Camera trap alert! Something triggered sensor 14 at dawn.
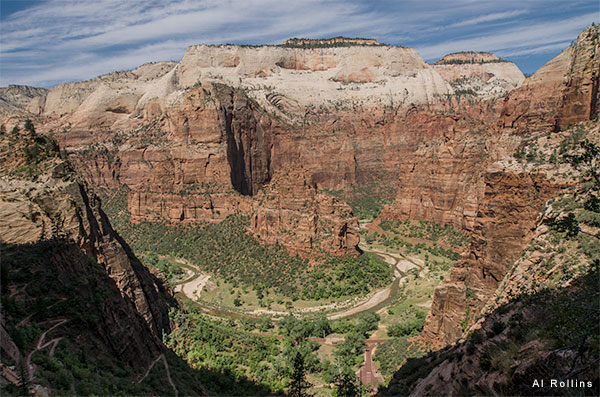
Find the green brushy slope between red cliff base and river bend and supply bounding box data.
[103,187,391,300]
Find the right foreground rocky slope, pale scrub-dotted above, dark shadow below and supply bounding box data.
[380,131,600,396]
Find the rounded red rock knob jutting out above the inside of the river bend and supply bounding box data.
[250,167,359,255]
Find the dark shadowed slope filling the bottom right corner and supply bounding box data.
[377,272,600,396]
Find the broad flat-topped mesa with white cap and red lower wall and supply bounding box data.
[0,43,514,251]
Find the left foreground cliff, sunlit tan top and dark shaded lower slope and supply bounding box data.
[0,132,203,394]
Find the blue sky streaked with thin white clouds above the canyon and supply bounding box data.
[0,0,600,87]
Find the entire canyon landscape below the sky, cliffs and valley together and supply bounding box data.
[0,24,600,396]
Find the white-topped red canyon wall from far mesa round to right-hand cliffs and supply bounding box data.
[1,26,600,372]
